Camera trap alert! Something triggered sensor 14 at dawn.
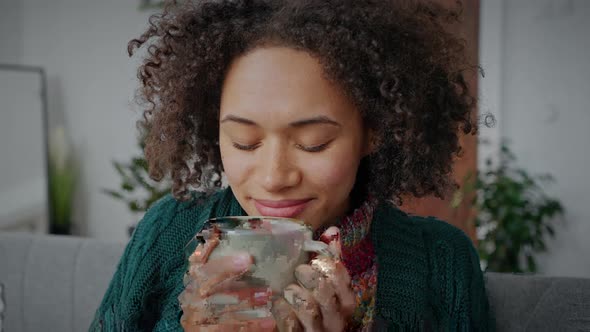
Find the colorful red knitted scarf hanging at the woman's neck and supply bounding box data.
[314,200,377,331]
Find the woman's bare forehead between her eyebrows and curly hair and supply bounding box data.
[221,47,356,121]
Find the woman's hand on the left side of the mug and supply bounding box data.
[179,230,275,332]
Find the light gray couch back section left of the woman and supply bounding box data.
[0,233,124,332]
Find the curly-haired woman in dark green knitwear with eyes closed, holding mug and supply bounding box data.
[91,0,492,331]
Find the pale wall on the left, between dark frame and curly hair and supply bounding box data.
[0,0,155,240]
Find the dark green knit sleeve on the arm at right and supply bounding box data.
[429,219,494,331]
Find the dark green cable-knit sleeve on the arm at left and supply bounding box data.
[89,195,177,331]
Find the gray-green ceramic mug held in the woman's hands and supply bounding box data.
[185,216,331,320]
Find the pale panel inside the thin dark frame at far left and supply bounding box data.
[0,69,47,232]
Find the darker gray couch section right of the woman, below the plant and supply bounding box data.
[486,273,590,332]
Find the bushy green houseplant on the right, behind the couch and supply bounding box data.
[462,142,563,273]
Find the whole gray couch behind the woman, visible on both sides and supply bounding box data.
[0,233,590,332]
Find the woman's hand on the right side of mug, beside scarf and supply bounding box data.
[273,227,356,332]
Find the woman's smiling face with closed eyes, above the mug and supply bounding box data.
[219,47,368,229]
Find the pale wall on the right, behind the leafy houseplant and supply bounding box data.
[480,0,590,277]
